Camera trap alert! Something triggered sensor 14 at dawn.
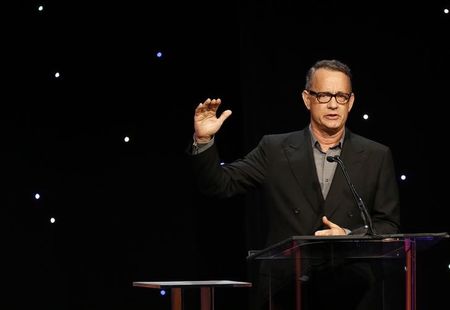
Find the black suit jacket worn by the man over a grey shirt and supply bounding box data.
[192,128,400,245]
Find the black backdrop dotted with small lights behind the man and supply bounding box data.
[0,0,450,310]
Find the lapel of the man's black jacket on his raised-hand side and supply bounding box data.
[284,129,324,213]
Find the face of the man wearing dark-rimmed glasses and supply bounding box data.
[302,68,355,134]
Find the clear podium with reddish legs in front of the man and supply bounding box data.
[247,232,449,310]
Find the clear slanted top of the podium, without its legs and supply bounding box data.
[247,232,450,260]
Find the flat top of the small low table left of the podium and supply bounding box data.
[133,280,252,288]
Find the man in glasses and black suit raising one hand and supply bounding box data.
[191,60,400,309]
